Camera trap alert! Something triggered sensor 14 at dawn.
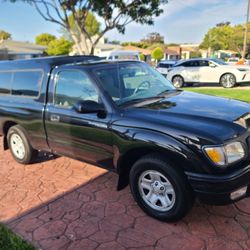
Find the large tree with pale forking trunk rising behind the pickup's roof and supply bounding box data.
[9,0,168,54]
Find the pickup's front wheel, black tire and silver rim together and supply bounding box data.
[129,155,194,222]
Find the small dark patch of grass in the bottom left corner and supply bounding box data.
[0,224,35,250]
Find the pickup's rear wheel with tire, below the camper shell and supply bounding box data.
[7,125,38,164]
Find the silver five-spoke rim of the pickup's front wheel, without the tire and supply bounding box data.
[138,170,176,212]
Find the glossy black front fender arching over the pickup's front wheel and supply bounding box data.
[113,126,206,189]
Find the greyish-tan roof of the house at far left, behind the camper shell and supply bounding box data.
[0,40,47,54]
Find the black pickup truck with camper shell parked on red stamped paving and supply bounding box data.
[0,56,250,221]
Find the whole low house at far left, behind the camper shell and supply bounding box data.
[0,40,47,60]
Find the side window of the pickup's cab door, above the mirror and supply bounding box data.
[54,70,99,108]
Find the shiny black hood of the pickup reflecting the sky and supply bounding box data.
[119,91,250,143]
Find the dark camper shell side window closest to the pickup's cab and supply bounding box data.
[12,71,43,97]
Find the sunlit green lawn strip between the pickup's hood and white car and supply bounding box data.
[184,88,250,102]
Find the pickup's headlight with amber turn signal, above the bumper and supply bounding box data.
[204,142,245,166]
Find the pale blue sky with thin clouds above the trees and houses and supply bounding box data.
[0,0,247,43]
